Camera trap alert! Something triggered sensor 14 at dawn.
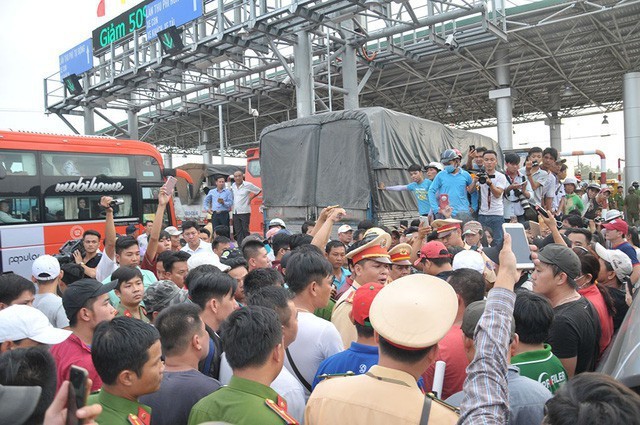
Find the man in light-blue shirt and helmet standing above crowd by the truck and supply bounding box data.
[429,149,476,222]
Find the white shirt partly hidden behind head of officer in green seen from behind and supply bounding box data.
[219,353,307,425]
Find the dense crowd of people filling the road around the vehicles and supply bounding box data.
[0,148,640,425]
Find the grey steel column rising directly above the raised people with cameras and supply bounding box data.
[494,46,513,150]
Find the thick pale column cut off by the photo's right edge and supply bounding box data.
[622,72,640,187]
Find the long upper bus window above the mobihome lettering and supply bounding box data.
[42,153,131,177]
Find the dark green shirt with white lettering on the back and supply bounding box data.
[511,344,568,394]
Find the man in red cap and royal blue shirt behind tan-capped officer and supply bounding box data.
[312,283,384,388]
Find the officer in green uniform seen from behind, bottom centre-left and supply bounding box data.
[189,305,298,425]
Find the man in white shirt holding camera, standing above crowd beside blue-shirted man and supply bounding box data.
[474,150,508,246]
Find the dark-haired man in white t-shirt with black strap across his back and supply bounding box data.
[285,248,343,398]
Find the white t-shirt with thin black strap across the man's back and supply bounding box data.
[284,311,343,399]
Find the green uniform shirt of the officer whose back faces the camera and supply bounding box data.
[189,375,284,425]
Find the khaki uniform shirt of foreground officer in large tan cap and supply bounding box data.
[304,366,458,425]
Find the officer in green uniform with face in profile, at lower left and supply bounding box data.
[88,317,164,425]
